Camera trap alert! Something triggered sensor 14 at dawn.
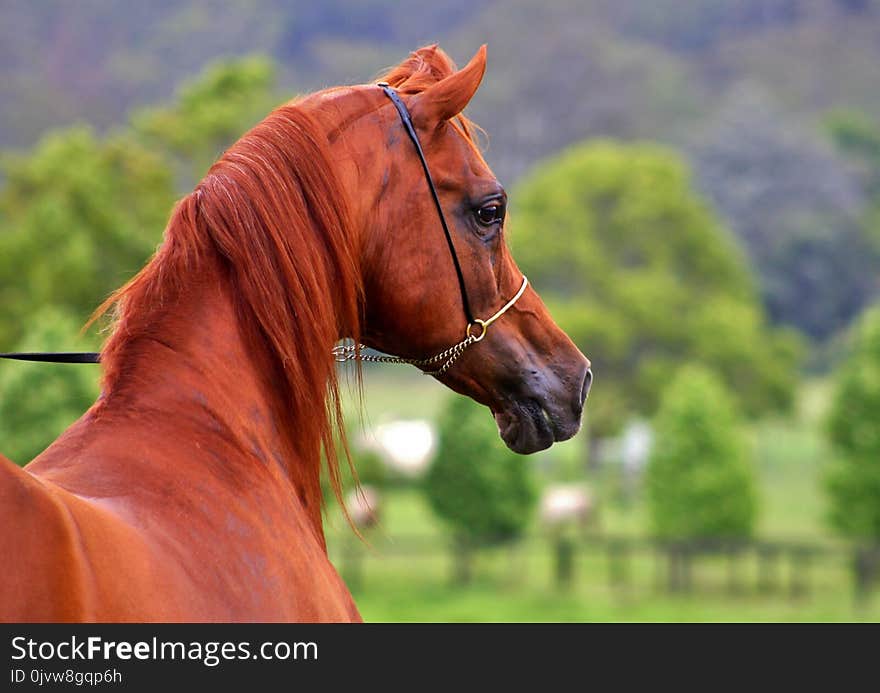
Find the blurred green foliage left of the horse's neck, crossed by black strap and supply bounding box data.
[0,59,288,475]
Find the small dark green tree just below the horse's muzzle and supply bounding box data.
[424,397,537,581]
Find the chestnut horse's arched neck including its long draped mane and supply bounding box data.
[55,105,362,534]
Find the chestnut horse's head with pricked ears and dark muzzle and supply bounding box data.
[326,46,592,453]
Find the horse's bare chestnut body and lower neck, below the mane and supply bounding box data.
[0,262,359,621]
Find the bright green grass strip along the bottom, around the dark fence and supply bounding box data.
[330,491,880,621]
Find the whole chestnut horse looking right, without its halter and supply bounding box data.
[0,46,589,621]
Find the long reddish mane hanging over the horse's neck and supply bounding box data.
[92,103,362,512]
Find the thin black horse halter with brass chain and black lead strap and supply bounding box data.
[0,82,529,375]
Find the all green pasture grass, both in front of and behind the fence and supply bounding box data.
[327,368,880,621]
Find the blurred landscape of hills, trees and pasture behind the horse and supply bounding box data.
[0,0,880,621]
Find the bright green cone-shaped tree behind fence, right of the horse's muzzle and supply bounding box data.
[645,366,757,539]
